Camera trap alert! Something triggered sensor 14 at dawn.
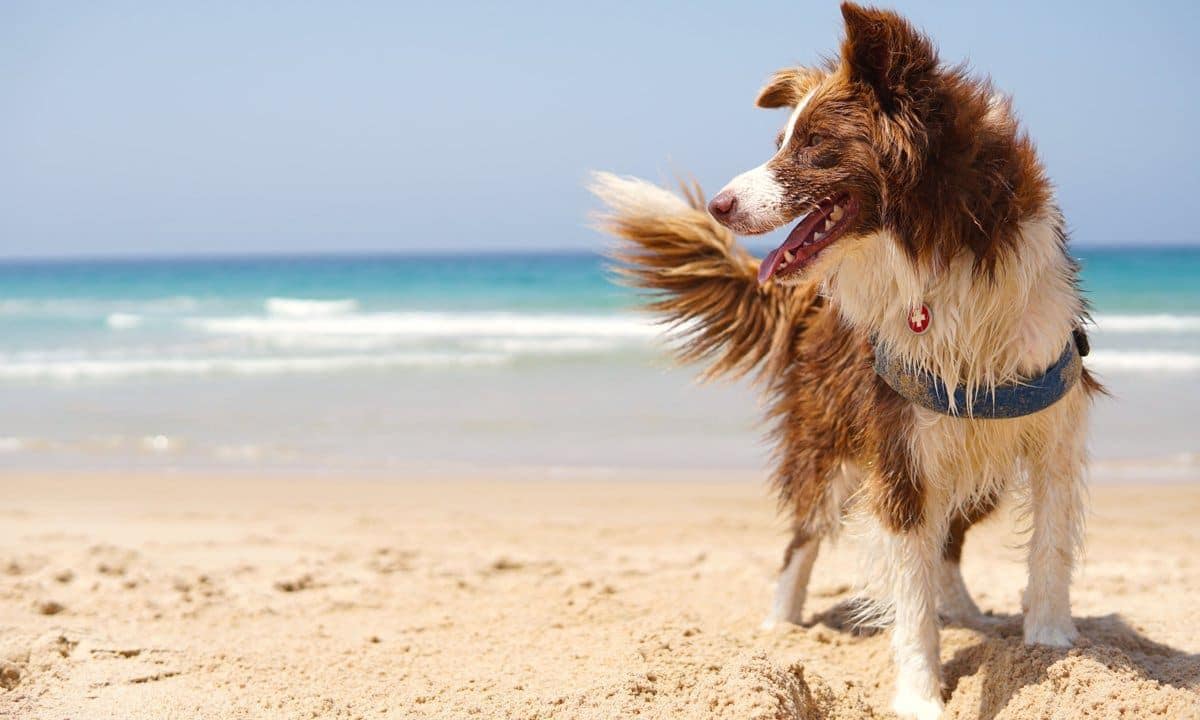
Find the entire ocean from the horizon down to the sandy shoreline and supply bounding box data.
[0,248,1200,476]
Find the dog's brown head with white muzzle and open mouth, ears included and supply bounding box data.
[709,2,960,282]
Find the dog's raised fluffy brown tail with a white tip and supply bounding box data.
[590,173,815,379]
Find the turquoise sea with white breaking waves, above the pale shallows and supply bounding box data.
[0,248,1200,380]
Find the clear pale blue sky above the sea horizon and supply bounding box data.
[0,0,1200,257]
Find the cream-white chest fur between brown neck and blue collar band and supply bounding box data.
[827,211,1082,410]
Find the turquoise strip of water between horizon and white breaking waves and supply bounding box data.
[7,247,1200,318]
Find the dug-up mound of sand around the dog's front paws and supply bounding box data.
[496,617,1200,720]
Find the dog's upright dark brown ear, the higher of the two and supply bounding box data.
[841,2,937,113]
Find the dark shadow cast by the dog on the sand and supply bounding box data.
[804,599,1200,720]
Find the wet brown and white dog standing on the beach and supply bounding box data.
[593,4,1102,719]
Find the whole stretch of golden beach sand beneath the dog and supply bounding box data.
[0,470,1200,720]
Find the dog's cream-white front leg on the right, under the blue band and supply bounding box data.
[1024,415,1085,648]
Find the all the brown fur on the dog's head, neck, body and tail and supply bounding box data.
[590,4,1103,619]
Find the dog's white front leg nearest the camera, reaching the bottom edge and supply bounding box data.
[886,520,944,720]
